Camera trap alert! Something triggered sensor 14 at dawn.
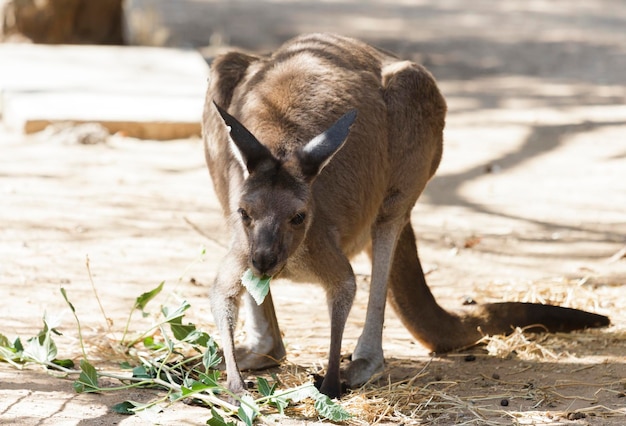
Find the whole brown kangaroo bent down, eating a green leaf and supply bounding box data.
[203,34,609,397]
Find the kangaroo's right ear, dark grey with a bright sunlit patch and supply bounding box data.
[298,109,357,180]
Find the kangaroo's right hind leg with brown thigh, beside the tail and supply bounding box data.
[346,61,446,386]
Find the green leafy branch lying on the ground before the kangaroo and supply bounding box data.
[0,266,350,426]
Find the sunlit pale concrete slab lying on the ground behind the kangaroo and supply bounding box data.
[0,44,209,140]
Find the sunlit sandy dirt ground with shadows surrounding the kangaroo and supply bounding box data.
[0,1,626,425]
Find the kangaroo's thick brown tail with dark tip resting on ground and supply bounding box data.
[388,223,609,352]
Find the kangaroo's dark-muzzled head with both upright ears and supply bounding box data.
[216,104,356,276]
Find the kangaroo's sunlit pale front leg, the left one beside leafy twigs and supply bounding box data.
[209,251,246,394]
